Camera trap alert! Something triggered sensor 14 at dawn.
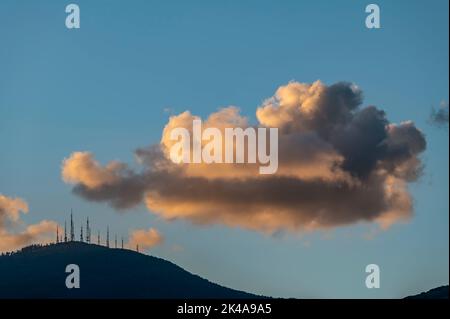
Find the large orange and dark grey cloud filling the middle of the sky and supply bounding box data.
[62,81,426,233]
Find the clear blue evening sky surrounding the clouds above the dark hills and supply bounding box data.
[0,0,449,298]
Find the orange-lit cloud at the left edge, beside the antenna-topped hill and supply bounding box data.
[0,194,57,251]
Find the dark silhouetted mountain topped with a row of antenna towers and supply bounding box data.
[0,242,259,299]
